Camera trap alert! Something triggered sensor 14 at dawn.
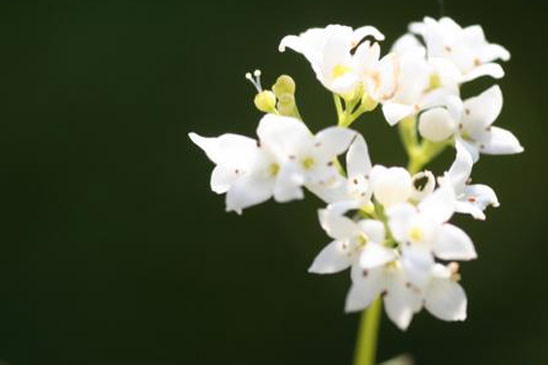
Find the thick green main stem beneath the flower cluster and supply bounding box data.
[354,297,382,365]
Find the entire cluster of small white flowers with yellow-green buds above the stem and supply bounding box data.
[189,17,523,329]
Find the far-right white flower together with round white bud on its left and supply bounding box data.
[419,85,523,161]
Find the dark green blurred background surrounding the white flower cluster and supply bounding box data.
[0,0,548,365]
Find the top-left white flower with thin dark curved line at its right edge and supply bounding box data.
[279,25,384,94]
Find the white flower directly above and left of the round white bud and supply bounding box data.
[382,40,460,125]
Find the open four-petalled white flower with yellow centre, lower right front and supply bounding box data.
[386,186,477,287]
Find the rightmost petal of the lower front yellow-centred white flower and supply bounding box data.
[434,223,478,260]
